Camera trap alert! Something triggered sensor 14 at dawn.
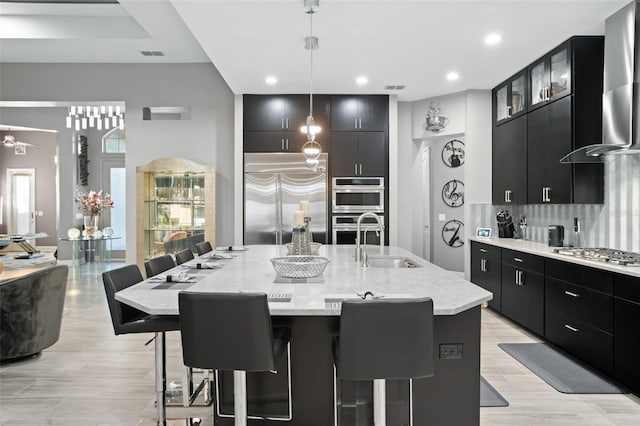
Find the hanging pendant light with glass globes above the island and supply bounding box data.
[300,0,322,170]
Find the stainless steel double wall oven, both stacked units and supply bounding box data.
[331,176,385,244]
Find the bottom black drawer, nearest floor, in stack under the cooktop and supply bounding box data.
[544,310,613,375]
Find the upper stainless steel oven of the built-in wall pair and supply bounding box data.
[331,177,384,213]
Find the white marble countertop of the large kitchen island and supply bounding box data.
[116,245,493,315]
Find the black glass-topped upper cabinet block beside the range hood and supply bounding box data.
[492,36,604,204]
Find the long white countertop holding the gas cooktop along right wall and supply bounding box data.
[469,237,640,277]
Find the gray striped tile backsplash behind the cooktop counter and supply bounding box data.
[468,155,640,252]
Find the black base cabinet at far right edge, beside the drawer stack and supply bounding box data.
[613,274,640,395]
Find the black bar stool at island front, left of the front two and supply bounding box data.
[178,292,291,426]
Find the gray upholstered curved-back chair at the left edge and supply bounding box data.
[0,265,69,361]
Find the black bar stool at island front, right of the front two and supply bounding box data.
[333,297,434,426]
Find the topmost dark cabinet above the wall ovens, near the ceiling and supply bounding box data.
[331,95,389,132]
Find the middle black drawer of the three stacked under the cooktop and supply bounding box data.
[545,276,613,333]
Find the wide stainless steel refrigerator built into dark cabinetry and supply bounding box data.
[244,153,327,244]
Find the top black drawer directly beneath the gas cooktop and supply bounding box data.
[544,259,613,294]
